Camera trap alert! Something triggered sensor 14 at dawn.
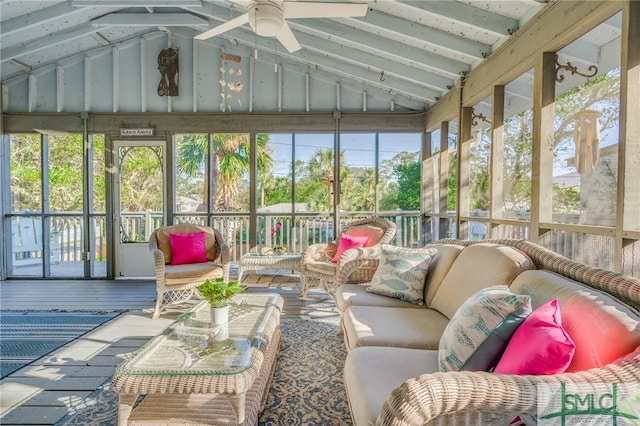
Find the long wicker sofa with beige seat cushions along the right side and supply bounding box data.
[336,240,640,425]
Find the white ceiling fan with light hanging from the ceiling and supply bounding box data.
[194,0,368,52]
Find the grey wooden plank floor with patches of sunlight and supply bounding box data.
[0,274,338,426]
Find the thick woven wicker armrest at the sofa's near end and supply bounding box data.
[376,348,640,425]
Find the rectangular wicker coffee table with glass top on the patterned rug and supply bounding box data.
[111,294,283,426]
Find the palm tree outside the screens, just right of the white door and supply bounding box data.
[177,133,273,211]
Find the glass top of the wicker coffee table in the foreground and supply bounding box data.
[116,293,282,376]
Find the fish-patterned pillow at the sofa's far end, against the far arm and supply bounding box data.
[367,244,437,305]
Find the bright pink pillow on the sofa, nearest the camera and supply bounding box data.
[493,299,576,374]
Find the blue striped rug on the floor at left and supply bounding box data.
[0,312,119,378]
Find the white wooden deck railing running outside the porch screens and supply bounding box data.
[10,212,640,277]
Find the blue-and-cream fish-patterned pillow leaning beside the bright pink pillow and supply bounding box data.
[438,286,531,371]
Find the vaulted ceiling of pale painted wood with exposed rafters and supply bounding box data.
[0,0,545,110]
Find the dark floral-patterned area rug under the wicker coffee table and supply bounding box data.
[56,318,352,426]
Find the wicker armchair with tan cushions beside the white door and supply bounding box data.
[149,224,229,319]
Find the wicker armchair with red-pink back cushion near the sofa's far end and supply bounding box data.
[301,218,396,297]
